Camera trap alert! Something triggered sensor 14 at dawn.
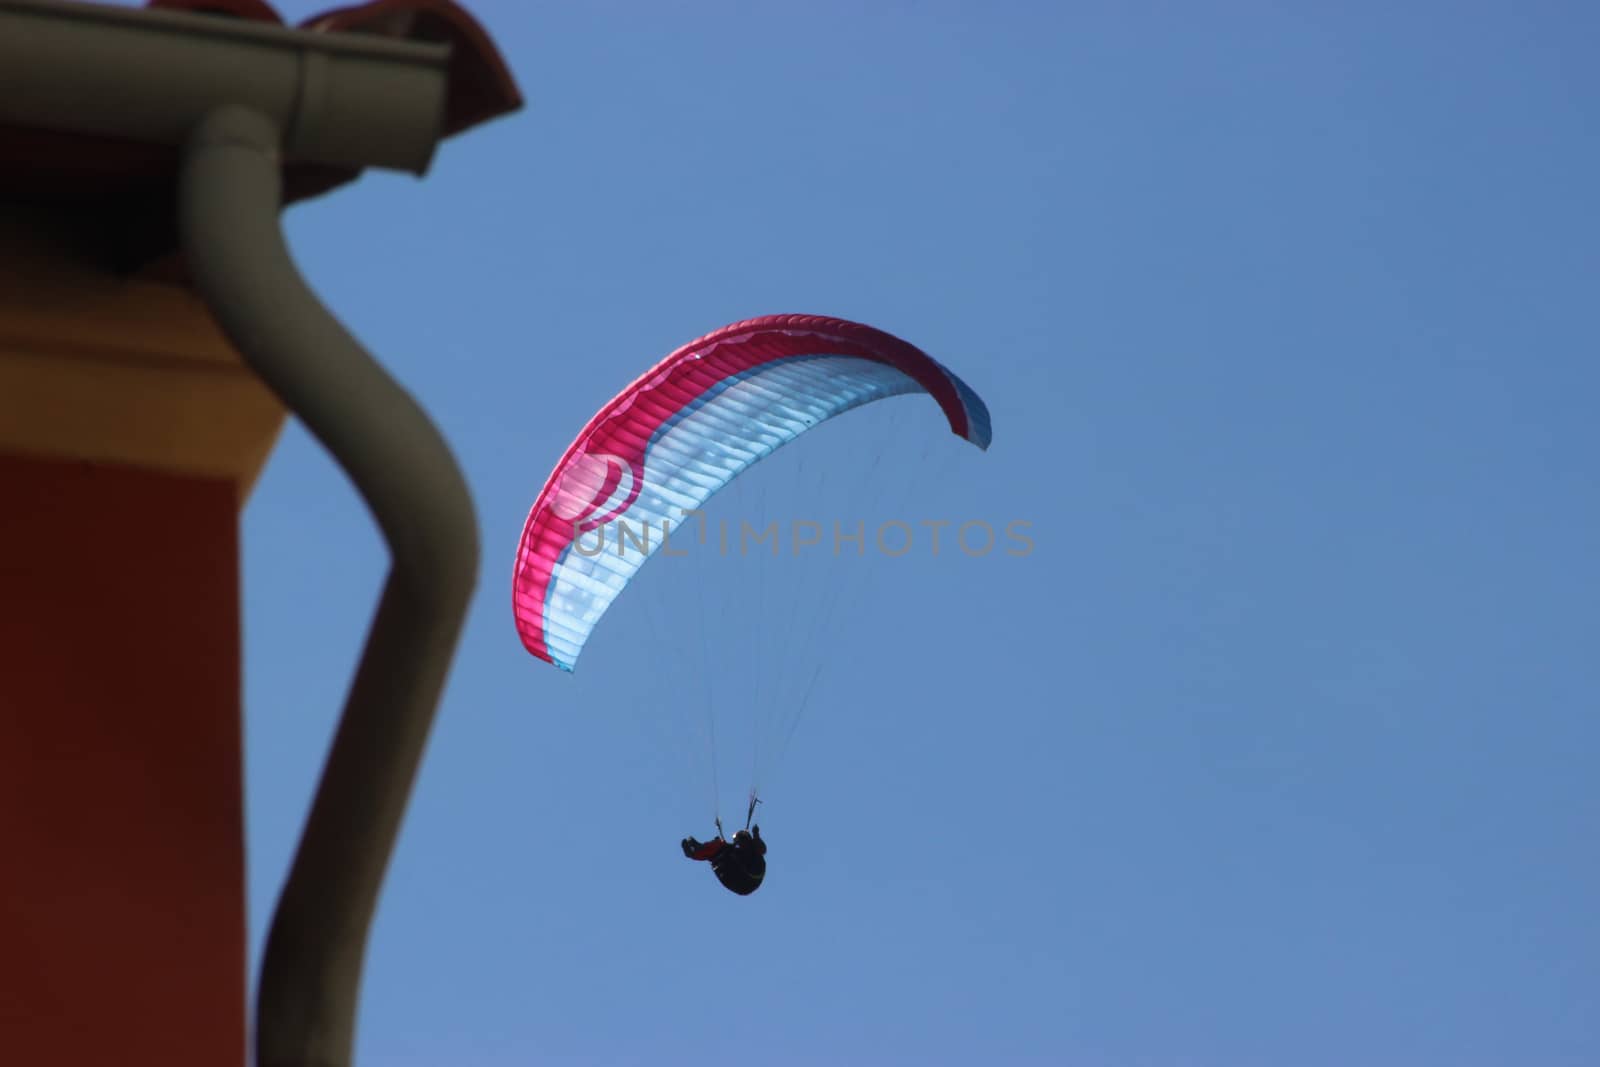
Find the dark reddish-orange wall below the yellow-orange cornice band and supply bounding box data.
[0,454,246,1067]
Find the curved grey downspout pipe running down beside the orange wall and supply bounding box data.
[179,106,478,1067]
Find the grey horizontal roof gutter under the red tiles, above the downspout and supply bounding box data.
[0,0,450,174]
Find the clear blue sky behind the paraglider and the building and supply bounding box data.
[228,0,1600,1067]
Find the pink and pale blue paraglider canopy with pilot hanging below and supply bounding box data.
[512,315,990,896]
